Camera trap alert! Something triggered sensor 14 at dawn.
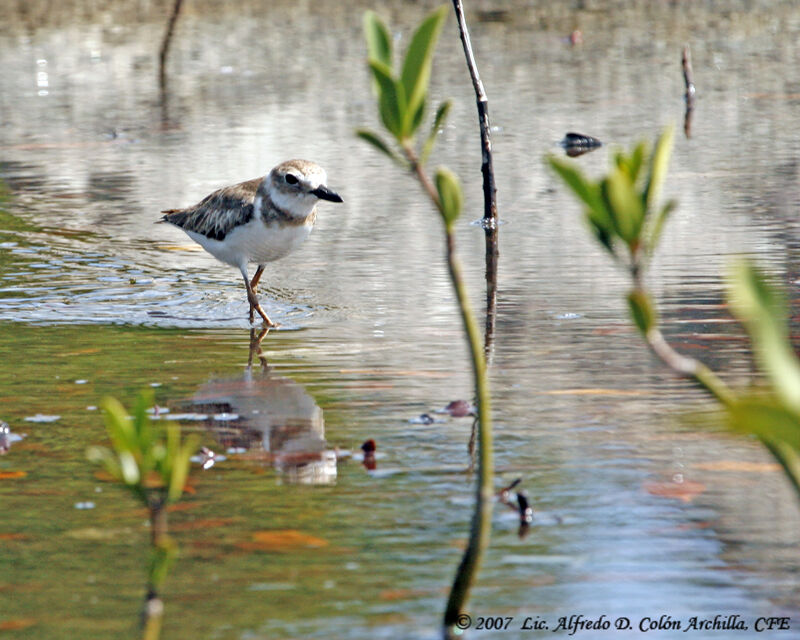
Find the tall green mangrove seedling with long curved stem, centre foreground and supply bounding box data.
[357,6,494,638]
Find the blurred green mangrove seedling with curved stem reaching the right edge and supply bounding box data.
[549,128,800,497]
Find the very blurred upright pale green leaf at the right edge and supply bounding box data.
[729,260,800,412]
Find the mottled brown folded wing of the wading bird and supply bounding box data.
[159,178,263,240]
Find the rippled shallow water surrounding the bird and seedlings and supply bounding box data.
[0,2,800,638]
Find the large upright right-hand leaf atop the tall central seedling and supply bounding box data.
[400,5,448,136]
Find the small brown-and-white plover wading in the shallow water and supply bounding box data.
[159,160,342,326]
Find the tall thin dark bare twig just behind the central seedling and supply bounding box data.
[453,0,499,357]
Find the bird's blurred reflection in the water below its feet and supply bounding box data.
[181,328,336,484]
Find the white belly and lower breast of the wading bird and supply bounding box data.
[186,218,312,268]
